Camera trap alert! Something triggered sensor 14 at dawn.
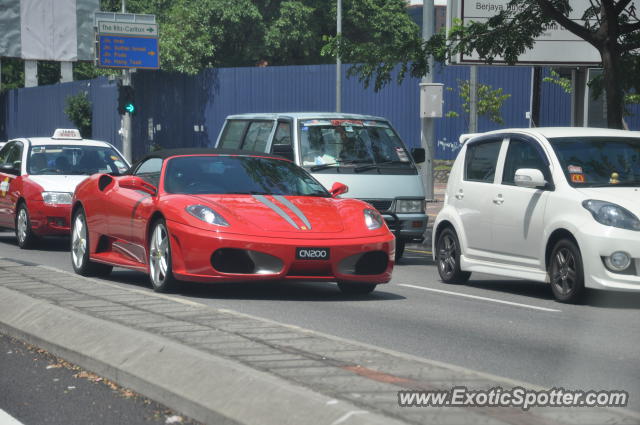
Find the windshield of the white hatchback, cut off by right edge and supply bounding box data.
[549,137,640,187]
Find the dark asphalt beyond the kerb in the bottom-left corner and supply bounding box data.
[0,334,196,425]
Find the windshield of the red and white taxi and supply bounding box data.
[27,145,128,175]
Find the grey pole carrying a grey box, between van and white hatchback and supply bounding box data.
[420,0,435,201]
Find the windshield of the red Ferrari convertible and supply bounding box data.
[164,155,331,197]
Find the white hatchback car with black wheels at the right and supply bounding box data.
[433,127,640,302]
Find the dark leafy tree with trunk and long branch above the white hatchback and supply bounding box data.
[334,0,640,128]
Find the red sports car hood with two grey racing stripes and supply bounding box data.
[194,195,344,233]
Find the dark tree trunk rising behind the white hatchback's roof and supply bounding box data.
[600,42,624,128]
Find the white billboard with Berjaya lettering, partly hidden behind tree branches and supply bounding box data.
[447,0,601,65]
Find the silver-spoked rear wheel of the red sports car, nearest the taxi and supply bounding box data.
[69,208,113,276]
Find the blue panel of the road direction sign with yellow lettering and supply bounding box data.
[98,34,160,69]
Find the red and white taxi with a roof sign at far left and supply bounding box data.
[0,129,129,248]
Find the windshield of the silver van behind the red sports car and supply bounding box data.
[299,119,413,171]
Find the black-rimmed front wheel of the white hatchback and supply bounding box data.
[547,239,585,303]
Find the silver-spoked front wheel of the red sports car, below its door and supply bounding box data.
[149,219,178,292]
